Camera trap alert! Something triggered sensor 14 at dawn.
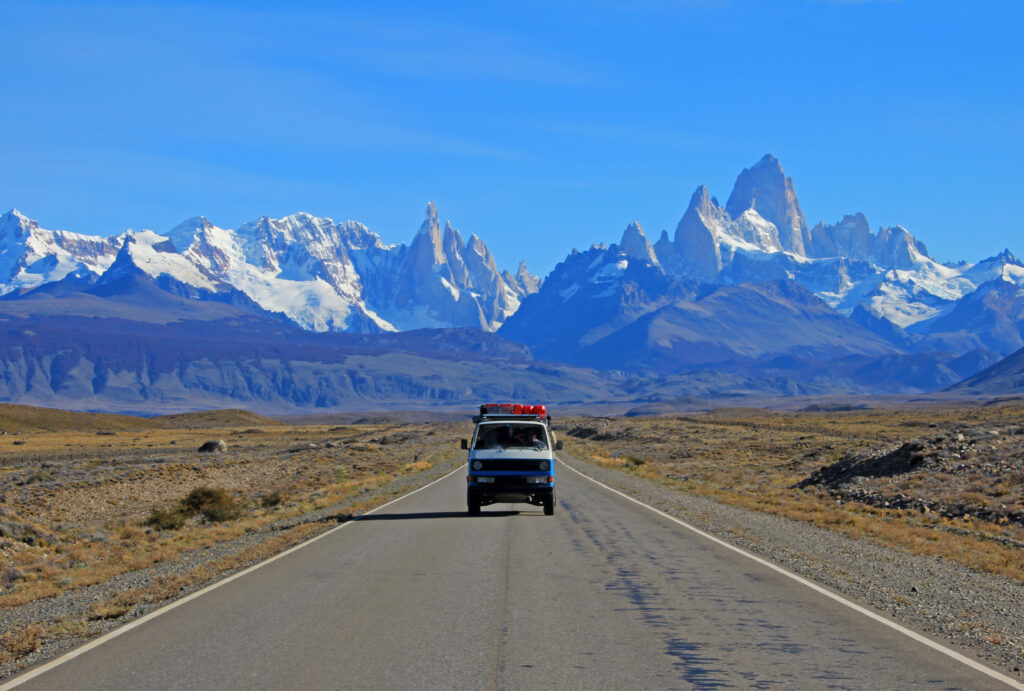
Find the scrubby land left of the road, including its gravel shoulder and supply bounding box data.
[0,405,471,678]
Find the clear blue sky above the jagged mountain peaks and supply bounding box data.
[0,0,1024,274]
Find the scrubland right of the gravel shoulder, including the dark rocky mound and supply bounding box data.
[558,403,1024,581]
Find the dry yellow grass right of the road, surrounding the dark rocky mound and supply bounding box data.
[559,406,1024,580]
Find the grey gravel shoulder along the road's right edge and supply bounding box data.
[561,455,1024,682]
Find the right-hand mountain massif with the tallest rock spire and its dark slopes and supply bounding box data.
[498,156,1024,393]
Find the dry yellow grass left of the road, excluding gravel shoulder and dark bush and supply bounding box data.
[0,412,468,608]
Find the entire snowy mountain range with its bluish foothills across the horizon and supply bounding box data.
[0,156,1024,412]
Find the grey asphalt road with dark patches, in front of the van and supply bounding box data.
[6,456,1007,689]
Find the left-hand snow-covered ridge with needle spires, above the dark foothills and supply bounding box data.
[0,203,541,333]
